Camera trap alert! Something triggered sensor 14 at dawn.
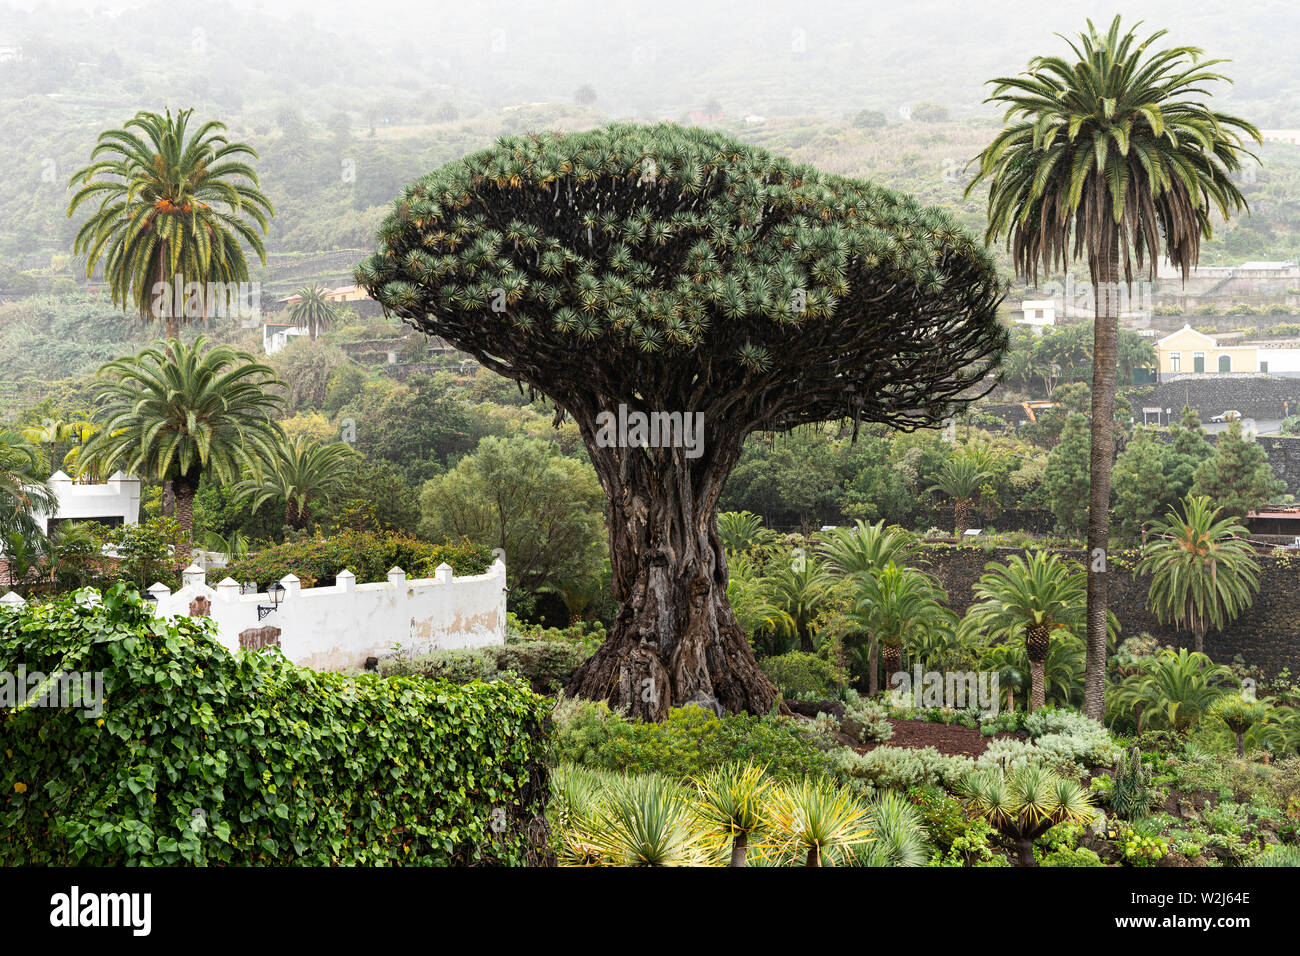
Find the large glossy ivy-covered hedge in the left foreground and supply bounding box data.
[0,584,550,866]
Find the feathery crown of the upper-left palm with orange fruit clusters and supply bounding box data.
[68,109,274,339]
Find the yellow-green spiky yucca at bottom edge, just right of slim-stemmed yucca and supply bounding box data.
[771,778,871,866]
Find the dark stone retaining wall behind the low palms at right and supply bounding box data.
[923,544,1300,675]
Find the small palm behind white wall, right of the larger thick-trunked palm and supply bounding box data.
[234,434,358,531]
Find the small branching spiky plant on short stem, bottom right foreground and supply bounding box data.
[961,763,1097,866]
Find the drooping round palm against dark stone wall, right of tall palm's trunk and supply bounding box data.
[1138,496,1260,653]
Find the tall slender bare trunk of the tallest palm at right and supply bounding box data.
[1083,227,1119,721]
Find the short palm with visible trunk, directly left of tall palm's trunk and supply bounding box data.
[967,551,1086,710]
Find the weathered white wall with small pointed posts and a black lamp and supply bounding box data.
[150,558,506,670]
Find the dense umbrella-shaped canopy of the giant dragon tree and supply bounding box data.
[356,124,1006,431]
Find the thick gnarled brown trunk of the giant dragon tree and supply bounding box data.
[566,440,777,721]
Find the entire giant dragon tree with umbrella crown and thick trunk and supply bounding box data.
[356,125,1006,719]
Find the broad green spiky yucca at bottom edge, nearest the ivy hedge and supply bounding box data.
[588,774,711,866]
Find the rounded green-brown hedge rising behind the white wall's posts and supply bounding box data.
[208,531,493,588]
